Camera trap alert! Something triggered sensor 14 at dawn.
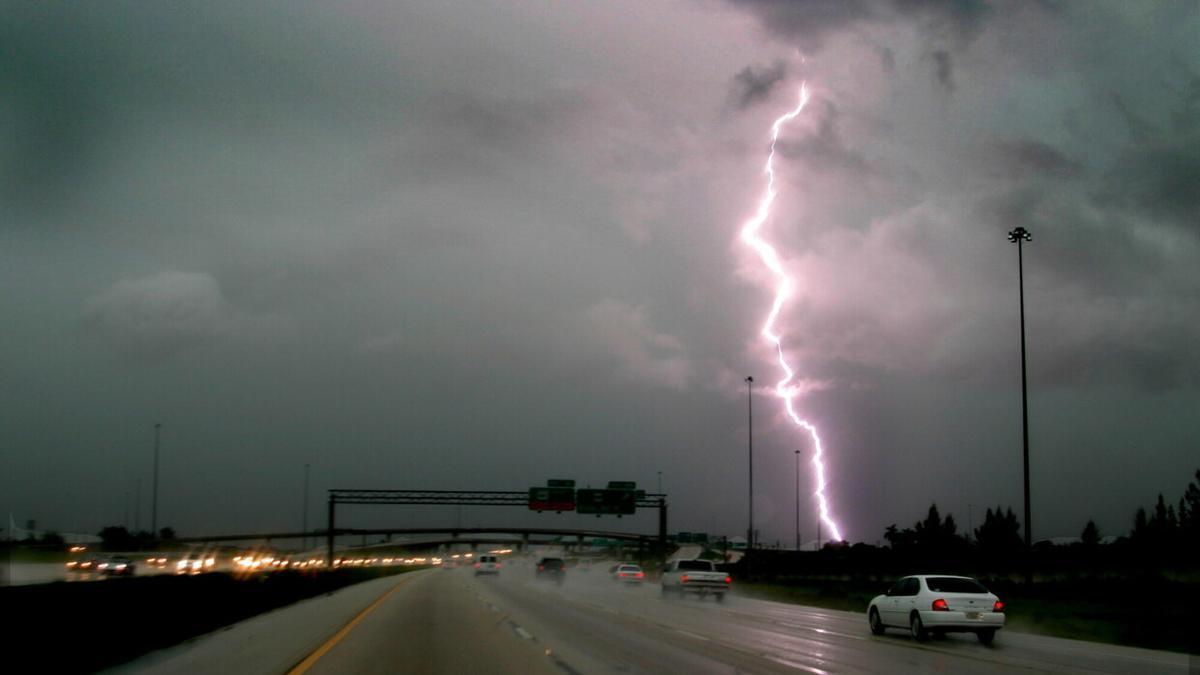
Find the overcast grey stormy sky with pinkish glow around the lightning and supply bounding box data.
[0,0,1200,542]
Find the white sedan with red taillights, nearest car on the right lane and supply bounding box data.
[866,574,1004,645]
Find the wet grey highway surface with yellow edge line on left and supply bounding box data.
[116,561,1189,675]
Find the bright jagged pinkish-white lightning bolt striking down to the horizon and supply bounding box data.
[742,84,842,542]
